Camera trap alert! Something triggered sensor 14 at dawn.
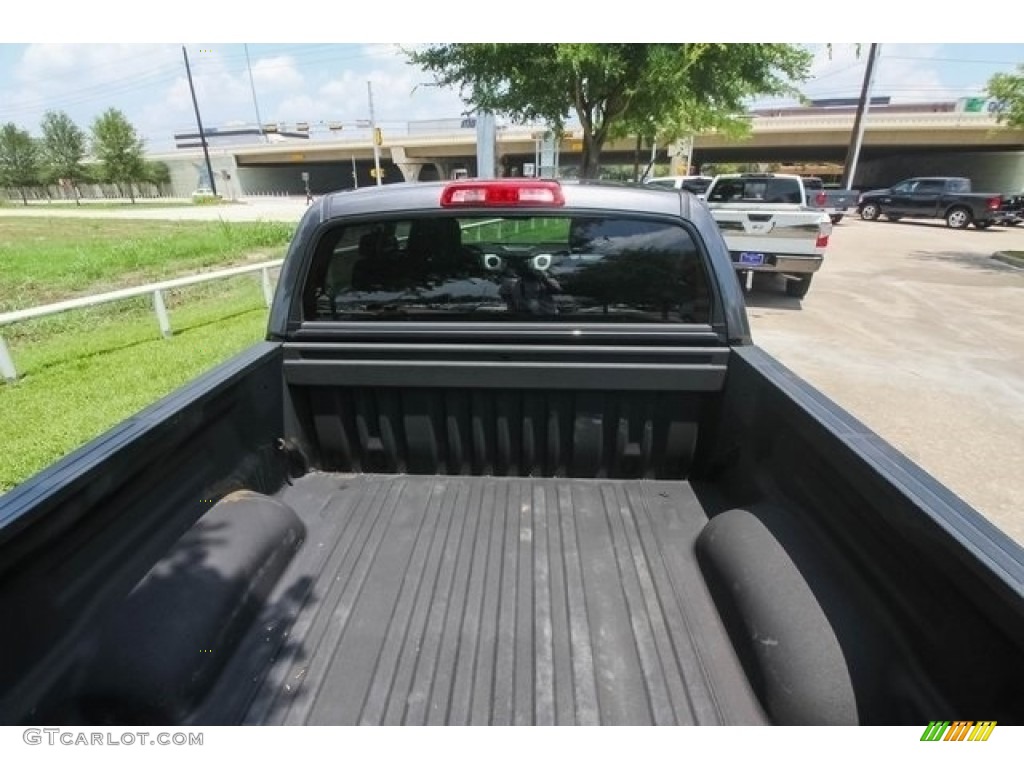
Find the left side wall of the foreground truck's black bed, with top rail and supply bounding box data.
[0,343,284,723]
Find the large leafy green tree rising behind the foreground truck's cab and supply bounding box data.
[407,43,812,178]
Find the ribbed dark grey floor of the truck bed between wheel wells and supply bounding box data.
[228,474,764,725]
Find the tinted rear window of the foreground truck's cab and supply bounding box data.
[303,216,711,324]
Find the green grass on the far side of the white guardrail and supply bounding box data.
[0,217,294,312]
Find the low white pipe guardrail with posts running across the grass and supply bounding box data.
[0,259,284,381]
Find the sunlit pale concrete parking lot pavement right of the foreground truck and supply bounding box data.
[746,219,1024,545]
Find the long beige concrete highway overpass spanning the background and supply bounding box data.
[153,108,1024,197]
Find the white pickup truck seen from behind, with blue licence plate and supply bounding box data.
[703,173,833,298]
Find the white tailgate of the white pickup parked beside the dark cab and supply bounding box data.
[712,208,831,256]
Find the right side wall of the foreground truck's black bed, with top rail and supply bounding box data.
[711,347,1024,723]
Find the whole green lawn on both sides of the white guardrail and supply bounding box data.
[0,219,290,493]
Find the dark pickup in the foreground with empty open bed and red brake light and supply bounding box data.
[0,180,1024,727]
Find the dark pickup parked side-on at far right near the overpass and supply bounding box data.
[857,176,1022,229]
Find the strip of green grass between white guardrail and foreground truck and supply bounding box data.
[0,278,267,493]
